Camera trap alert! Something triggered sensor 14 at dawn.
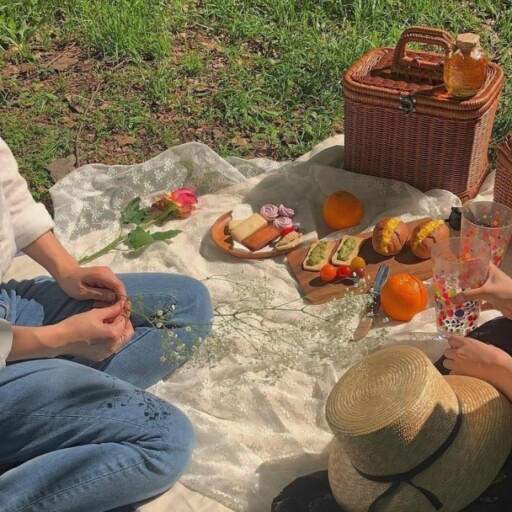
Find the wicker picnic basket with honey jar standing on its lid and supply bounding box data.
[343,27,504,201]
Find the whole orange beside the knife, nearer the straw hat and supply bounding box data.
[380,273,427,322]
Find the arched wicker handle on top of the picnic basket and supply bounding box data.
[391,26,455,80]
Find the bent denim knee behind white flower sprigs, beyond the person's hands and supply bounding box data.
[90,274,212,388]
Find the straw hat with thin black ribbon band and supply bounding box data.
[326,346,512,512]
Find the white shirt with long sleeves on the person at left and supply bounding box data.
[0,138,54,369]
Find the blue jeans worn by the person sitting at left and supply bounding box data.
[0,273,212,512]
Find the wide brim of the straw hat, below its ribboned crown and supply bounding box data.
[328,376,512,512]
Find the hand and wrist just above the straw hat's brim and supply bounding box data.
[443,336,512,400]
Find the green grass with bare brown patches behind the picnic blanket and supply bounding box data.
[0,0,512,210]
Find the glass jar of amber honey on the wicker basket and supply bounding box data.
[443,32,487,98]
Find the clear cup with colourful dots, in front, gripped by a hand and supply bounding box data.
[431,237,491,336]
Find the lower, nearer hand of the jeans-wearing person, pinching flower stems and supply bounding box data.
[56,301,134,361]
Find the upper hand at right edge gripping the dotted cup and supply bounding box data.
[454,263,512,319]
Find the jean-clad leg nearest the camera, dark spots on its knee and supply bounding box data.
[0,359,193,512]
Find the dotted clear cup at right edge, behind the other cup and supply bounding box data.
[460,201,512,266]
